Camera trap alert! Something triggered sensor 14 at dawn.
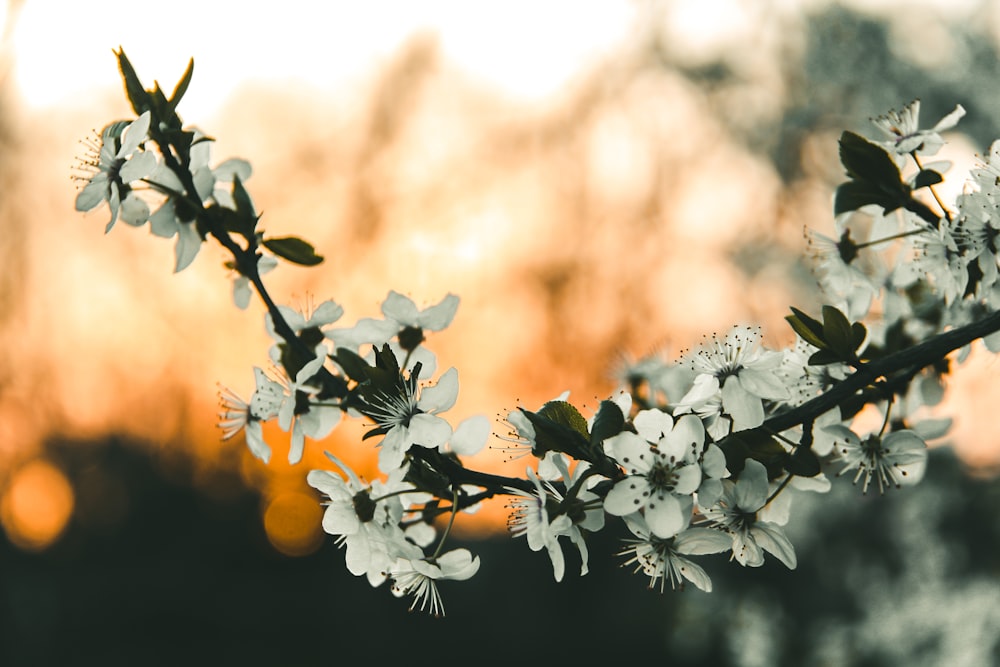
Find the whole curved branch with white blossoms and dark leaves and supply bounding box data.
[76,52,1000,614]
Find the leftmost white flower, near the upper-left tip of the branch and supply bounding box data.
[76,111,156,233]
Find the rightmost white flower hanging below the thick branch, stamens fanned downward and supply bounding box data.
[825,425,927,493]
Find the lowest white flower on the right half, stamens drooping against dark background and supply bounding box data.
[618,515,729,593]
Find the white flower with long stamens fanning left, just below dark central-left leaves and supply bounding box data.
[362,368,458,473]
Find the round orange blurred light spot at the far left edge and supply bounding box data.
[0,459,74,551]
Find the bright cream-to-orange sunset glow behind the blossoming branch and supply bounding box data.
[0,0,1000,553]
